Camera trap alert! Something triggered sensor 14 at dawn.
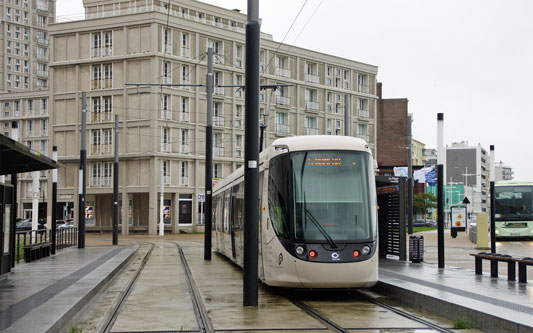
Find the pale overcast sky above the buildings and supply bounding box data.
[57,0,533,180]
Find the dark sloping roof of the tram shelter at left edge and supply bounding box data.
[0,134,60,175]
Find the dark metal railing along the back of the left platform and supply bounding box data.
[15,228,78,264]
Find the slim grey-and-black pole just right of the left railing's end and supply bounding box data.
[78,91,87,249]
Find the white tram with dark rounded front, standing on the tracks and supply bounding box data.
[213,135,378,288]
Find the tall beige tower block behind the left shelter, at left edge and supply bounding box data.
[0,0,56,218]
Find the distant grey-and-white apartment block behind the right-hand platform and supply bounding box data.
[445,141,490,213]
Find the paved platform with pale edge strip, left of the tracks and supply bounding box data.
[0,240,137,332]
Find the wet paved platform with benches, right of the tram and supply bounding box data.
[375,232,533,332]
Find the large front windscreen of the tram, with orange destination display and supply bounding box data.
[290,151,375,241]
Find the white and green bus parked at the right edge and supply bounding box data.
[494,181,533,239]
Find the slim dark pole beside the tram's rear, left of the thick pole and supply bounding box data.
[204,47,214,260]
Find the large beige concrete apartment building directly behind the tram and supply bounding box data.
[49,0,377,234]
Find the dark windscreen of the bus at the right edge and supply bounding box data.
[494,186,533,221]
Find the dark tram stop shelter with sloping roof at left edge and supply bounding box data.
[0,134,59,274]
